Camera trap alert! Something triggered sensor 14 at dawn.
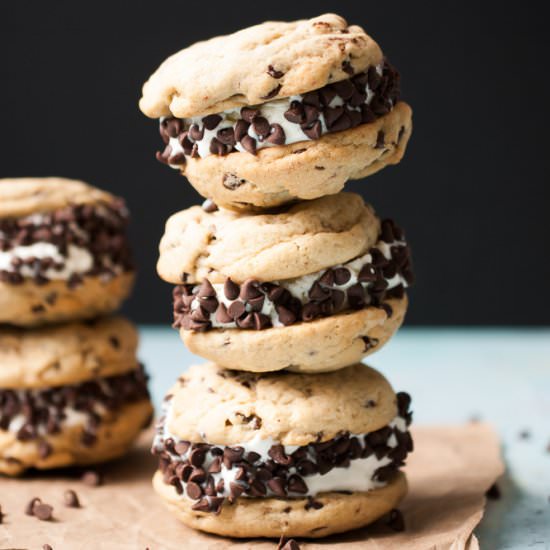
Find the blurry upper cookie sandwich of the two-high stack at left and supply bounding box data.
[0,178,134,326]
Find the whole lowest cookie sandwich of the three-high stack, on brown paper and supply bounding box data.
[153,364,413,537]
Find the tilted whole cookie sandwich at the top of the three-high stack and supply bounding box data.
[140,14,412,209]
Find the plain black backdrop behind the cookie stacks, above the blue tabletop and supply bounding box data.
[0,0,550,325]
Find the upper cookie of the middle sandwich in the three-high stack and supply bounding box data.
[157,193,380,284]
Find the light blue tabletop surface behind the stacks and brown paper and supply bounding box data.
[140,327,550,550]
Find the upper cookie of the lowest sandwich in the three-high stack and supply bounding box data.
[167,363,398,445]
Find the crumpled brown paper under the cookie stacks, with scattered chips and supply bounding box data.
[0,424,503,550]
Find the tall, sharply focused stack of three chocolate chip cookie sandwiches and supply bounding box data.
[140,14,413,537]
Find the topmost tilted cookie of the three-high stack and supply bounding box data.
[140,13,383,118]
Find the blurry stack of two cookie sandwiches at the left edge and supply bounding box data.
[0,178,152,475]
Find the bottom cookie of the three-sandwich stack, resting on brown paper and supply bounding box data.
[153,472,407,538]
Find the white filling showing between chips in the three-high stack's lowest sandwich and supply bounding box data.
[153,401,407,500]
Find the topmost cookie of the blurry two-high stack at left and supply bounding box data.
[0,178,115,218]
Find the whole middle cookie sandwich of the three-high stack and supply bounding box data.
[158,193,413,372]
